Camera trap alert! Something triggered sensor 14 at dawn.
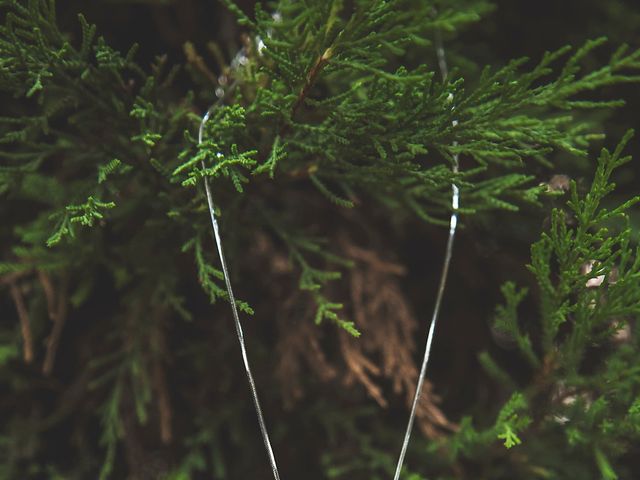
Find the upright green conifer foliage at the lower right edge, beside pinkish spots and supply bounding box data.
[436,134,640,478]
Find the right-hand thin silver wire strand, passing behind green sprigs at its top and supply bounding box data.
[393,34,460,480]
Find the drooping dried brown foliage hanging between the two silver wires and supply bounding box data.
[254,229,455,437]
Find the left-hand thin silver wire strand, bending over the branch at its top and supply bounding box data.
[198,82,280,480]
